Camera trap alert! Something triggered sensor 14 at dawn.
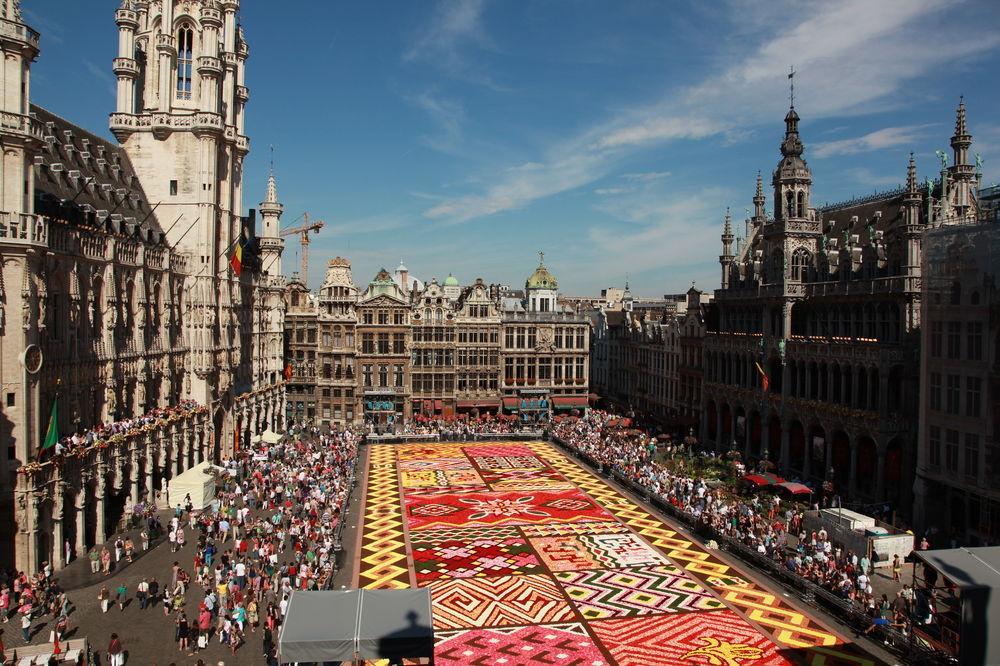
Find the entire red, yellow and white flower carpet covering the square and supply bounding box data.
[356,442,877,666]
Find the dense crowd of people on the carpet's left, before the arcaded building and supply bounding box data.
[129,428,360,661]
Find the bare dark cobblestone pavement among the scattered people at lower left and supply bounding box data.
[2,456,362,666]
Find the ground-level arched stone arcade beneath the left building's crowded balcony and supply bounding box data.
[15,407,215,573]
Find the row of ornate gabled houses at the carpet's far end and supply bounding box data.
[286,257,590,431]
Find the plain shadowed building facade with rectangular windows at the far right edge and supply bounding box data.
[914,220,1000,546]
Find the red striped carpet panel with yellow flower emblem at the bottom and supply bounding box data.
[589,610,791,666]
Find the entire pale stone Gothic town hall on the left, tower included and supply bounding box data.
[0,0,283,572]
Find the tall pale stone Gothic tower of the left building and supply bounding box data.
[110,0,252,404]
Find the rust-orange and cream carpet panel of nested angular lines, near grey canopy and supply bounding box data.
[430,575,576,630]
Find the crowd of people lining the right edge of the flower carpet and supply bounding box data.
[554,410,926,630]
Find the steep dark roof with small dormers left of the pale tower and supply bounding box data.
[31,104,163,242]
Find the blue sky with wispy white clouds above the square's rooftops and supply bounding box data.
[23,0,1000,296]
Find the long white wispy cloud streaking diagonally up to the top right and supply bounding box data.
[425,0,1000,223]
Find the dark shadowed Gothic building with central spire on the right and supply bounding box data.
[701,98,976,515]
